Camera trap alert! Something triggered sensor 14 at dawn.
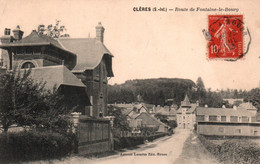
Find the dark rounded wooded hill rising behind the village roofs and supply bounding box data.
[108,78,196,105]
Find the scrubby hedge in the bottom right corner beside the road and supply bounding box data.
[199,135,260,164]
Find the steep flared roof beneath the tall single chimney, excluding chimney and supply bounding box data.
[58,38,113,77]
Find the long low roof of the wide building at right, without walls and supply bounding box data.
[197,107,255,117]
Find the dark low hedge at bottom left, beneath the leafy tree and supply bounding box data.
[0,131,75,163]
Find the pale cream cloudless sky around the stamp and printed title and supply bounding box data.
[0,0,260,90]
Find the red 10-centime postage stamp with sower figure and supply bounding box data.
[208,15,244,60]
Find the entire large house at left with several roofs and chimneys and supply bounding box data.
[0,23,113,118]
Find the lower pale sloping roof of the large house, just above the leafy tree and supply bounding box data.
[23,65,86,90]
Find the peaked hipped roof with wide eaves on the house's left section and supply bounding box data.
[0,31,76,56]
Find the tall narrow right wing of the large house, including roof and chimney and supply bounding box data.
[58,22,114,117]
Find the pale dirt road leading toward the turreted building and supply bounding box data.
[31,129,217,164]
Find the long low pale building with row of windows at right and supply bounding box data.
[196,107,260,136]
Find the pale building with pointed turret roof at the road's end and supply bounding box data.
[177,95,198,129]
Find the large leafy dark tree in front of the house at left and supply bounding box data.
[0,68,71,132]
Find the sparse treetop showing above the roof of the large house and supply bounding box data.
[37,19,69,38]
